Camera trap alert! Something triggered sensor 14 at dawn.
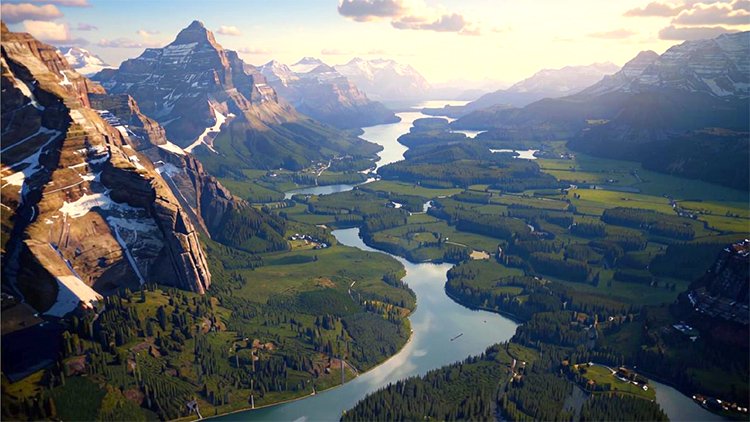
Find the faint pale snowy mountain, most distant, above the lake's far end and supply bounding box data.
[334,57,430,101]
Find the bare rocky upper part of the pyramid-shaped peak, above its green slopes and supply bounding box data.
[94,21,296,150]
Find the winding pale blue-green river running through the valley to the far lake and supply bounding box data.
[222,101,720,421]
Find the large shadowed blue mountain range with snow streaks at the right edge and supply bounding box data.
[452,32,750,189]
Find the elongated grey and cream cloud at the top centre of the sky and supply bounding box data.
[338,0,481,35]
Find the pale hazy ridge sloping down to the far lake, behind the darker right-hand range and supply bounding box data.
[428,62,620,117]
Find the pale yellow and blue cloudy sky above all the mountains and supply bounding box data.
[0,0,750,84]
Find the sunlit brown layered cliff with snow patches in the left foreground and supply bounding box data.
[1,25,211,316]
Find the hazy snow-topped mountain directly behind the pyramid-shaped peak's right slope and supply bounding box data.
[259,57,398,129]
